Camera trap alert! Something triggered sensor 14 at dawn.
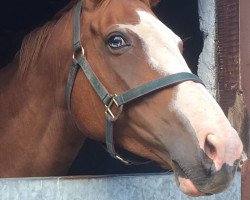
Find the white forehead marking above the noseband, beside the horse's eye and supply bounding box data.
[119,11,190,75]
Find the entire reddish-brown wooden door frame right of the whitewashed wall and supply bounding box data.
[217,0,250,200]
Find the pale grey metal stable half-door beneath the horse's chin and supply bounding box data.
[0,174,240,200]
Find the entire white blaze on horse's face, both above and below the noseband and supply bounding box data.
[119,11,240,169]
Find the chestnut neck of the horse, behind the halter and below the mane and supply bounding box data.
[0,7,84,177]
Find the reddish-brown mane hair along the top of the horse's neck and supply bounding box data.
[17,0,76,76]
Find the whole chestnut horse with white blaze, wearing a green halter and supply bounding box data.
[0,0,242,196]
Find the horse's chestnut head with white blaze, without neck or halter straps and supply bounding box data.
[70,0,242,196]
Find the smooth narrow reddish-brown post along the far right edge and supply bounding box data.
[239,0,250,200]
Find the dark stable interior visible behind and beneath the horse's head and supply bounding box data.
[0,0,203,175]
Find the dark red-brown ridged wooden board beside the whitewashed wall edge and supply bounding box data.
[216,0,239,115]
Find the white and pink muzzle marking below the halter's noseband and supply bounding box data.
[170,81,242,170]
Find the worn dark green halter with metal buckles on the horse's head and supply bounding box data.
[66,0,203,164]
